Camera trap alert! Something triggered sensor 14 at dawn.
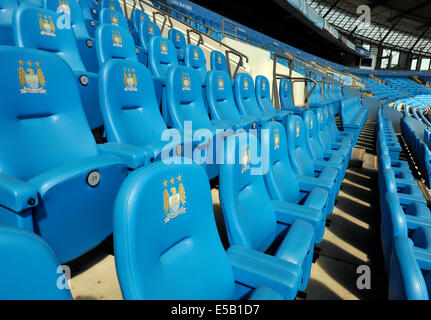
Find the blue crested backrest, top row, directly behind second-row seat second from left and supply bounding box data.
[95,24,138,66]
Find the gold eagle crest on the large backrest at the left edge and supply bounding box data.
[18,60,46,94]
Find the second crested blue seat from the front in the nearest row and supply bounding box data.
[219,132,315,290]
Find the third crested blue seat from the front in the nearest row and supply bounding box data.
[262,121,329,243]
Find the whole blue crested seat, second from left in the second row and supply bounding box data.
[99,58,192,169]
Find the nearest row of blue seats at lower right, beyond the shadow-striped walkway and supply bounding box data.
[377,108,431,300]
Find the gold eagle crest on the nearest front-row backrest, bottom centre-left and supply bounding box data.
[163,175,186,223]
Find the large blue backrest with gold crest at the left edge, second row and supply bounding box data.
[0,47,97,181]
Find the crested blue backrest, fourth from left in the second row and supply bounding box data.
[206,70,241,121]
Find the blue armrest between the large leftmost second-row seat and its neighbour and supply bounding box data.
[97,142,154,170]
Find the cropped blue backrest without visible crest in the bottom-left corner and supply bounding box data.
[0,226,72,300]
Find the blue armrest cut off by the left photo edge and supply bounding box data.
[0,173,38,212]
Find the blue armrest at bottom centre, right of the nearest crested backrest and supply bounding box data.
[227,246,302,300]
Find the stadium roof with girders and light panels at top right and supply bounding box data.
[306,0,431,56]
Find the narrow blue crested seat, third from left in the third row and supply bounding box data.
[148,36,178,127]
